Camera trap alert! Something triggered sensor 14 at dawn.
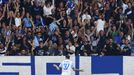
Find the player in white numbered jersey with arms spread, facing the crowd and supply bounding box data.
[53,55,83,75]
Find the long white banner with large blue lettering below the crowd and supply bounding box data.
[0,56,134,75]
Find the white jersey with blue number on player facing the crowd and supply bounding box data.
[59,60,74,75]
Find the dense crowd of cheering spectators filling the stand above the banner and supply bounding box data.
[0,0,134,56]
